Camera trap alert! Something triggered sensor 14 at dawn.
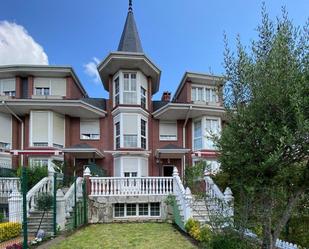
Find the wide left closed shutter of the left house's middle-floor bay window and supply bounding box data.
[31,112,49,143]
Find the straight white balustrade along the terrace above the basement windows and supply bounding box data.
[90,177,173,196]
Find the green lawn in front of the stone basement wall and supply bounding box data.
[50,223,197,249]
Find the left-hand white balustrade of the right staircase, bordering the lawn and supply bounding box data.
[173,167,192,222]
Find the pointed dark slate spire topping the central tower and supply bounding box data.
[118,6,143,53]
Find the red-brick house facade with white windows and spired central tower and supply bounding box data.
[0,2,225,180]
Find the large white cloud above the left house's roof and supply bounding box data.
[0,21,48,65]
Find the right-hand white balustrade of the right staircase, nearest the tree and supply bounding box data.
[204,171,234,217]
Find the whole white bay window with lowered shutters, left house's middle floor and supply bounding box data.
[30,111,65,148]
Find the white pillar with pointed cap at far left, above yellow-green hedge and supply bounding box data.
[8,189,23,223]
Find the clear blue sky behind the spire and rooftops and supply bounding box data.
[0,0,309,99]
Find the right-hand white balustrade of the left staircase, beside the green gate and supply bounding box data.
[64,177,83,217]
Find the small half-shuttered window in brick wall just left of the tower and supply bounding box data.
[80,119,100,140]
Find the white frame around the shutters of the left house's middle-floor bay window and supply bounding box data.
[29,110,66,149]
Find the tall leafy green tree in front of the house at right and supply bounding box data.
[217,4,309,249]
